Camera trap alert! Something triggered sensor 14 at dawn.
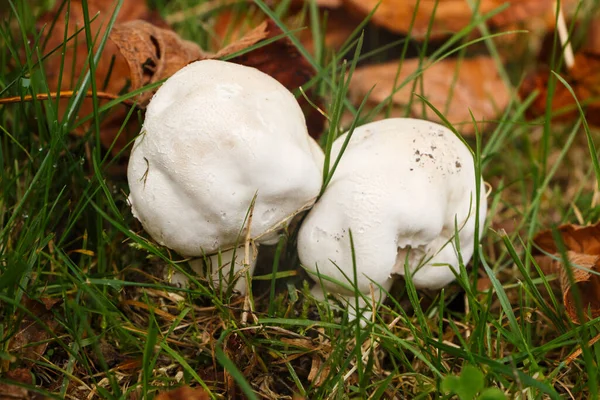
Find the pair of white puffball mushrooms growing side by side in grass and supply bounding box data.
[128,60,487,315]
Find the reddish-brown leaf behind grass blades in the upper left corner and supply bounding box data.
[37,0,167,153]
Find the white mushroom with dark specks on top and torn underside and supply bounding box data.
[298,118,487,318]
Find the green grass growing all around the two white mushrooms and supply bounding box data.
[0,0,600,399]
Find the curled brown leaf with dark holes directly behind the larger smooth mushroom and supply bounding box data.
[110,21,323,138]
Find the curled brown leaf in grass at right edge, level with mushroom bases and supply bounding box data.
[533,223,600,323]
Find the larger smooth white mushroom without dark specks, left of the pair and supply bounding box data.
[127,60,324,293]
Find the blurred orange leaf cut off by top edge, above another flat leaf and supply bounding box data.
[343,0,564,38]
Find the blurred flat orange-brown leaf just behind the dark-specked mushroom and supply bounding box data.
[350,56,510,134]
